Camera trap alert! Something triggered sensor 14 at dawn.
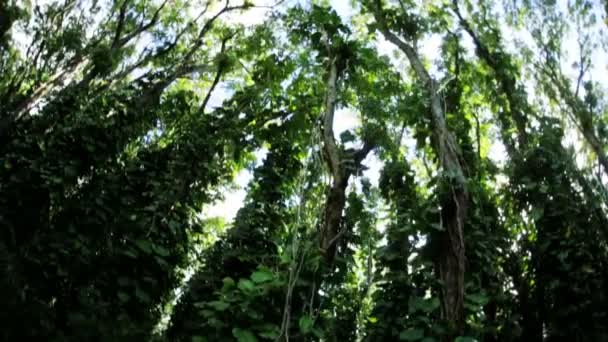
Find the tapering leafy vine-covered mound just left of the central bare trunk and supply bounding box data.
[168,124,300,341]
